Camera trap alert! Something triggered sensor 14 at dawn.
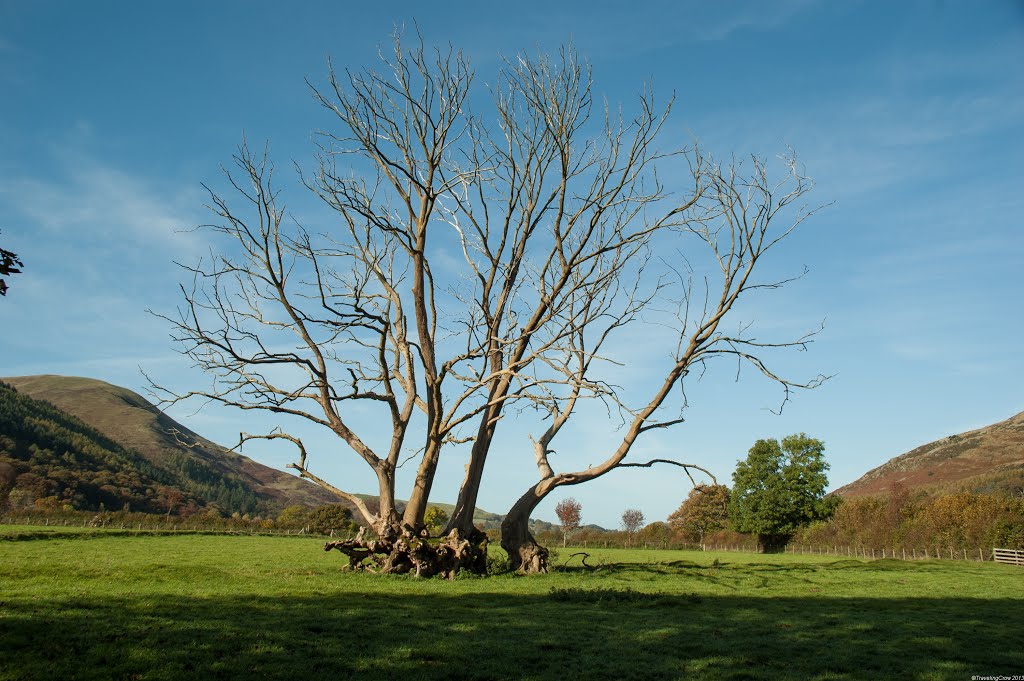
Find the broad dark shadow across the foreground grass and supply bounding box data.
[0,589,1024,680]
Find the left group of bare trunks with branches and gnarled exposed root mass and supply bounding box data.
[153,37,485,574]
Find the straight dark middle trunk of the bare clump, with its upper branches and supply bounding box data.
[444,50,697,528]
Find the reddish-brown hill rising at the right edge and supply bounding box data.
[833,412,1024,497]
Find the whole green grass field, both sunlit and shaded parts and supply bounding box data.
[0,527,1024,680]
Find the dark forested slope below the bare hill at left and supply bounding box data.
[0,382,269,514]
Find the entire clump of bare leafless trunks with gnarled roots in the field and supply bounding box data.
[154,31,823,574]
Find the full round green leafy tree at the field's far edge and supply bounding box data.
[729,433,833,552]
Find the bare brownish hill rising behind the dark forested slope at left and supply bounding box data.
[2,376,338,512]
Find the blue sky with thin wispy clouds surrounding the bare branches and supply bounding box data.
[0,0,1024,527]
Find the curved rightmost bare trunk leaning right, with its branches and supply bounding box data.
[502,152,827,571]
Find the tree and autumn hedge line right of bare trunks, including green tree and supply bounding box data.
[539,433,1024,551]
